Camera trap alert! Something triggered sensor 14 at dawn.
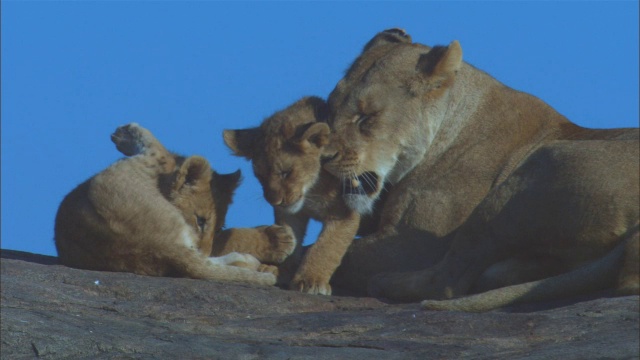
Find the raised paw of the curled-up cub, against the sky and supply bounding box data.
[111,123,175,173]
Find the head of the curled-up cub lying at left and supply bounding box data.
[159,156,240,255]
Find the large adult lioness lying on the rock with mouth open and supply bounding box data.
[325,29,640,311]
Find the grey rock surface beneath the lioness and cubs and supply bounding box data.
[0,250,640,360]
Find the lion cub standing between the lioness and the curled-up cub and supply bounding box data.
[224,97,360,295]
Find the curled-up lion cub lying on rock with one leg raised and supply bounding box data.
[55,124,276,285]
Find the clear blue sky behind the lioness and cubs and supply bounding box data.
[1,0,639,255]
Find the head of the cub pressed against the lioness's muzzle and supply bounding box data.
[223,97,329,213]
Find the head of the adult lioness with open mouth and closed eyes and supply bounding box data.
[325,29,462,213]
